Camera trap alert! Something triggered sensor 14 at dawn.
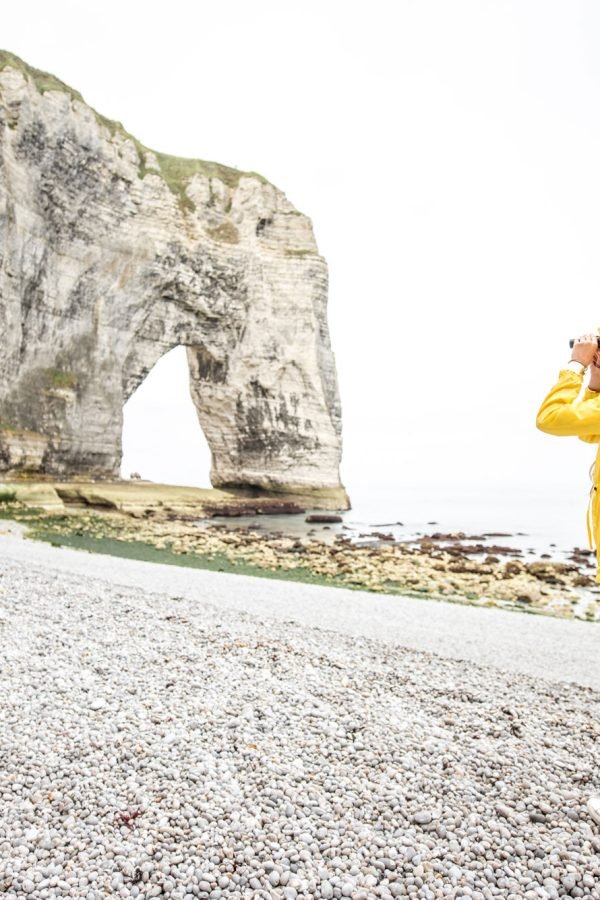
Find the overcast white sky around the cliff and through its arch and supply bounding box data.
[0,0,600,496]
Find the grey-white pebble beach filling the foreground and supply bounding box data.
[0,537,600,900]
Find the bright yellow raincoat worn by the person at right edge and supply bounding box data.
[535,369,600,584]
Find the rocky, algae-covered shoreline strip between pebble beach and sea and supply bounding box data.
[0,502,600,622]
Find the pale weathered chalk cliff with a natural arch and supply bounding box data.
[0,53,346,502]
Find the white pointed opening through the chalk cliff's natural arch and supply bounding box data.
[120,345,211,487]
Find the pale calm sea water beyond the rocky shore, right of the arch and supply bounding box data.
[200,481,589,560]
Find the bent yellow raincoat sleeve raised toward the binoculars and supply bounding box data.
[535,369,600,443]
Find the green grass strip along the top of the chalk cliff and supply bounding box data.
[0,50,270,209]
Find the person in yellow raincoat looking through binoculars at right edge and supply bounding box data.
[535,334,600,823]
